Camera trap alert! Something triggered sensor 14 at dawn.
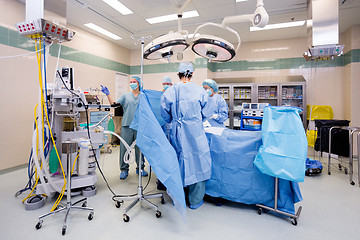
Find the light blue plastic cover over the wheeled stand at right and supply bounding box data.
[254,107,308,182]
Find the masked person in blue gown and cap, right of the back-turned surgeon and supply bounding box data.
[202,79,229,127]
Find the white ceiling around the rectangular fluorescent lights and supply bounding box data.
[45,0,360,49]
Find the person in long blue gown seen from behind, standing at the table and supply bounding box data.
[160,63,212,209]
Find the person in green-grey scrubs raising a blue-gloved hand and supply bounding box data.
[101,76,148,180]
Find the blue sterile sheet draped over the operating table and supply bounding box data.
[206,129,302,214]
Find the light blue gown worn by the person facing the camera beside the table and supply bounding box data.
[208,93,229,127]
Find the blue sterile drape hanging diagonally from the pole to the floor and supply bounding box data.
[130,90,186,218]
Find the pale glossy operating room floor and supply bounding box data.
[0,148,360,240]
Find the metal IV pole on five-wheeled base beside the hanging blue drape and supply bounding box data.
[117,37,165,222]
